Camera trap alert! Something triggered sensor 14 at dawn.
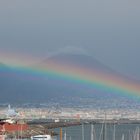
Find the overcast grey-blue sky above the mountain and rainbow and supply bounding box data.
[0,0,140,80]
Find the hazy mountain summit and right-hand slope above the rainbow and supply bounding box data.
[41,52,140,83]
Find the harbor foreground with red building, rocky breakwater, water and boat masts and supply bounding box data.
[0,117,140,140]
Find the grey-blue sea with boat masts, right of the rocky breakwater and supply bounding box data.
[54,124,140,140]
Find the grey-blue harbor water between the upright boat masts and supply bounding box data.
[54,124,140,140]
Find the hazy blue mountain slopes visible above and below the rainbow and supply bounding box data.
[0,52,140,107]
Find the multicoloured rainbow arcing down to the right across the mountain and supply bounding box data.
[1,51,140,98]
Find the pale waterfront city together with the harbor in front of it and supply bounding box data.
[0,105,140,140]
